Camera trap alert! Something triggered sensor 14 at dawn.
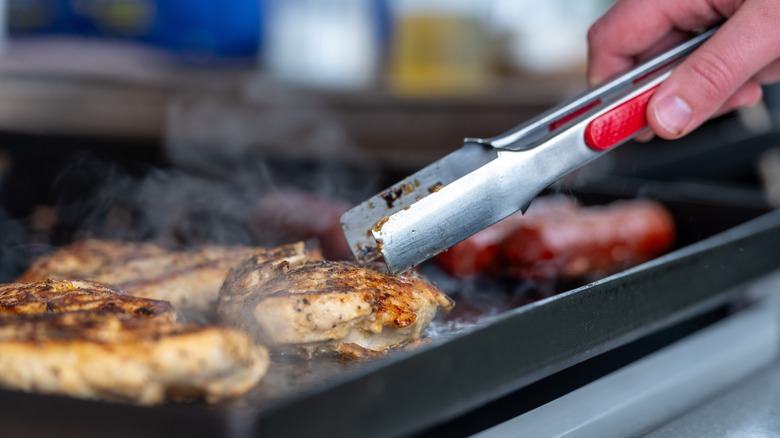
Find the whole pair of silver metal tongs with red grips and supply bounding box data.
[341,29,716,273]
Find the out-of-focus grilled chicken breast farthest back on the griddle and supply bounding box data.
[17,240,314,320]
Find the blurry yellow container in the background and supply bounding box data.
[389,11,490,97]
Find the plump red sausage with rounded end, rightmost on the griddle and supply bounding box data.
[498,200,675,280]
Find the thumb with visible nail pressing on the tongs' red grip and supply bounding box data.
[648,0,780,139]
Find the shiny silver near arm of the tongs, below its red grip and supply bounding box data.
[372,77,664,272]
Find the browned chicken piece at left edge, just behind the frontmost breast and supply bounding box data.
[0,280,176,322]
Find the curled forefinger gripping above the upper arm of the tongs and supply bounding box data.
[588,0,742,84]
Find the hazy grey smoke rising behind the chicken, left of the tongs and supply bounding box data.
[45,79,390,252]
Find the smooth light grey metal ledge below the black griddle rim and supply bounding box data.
[476,294,780,438]
